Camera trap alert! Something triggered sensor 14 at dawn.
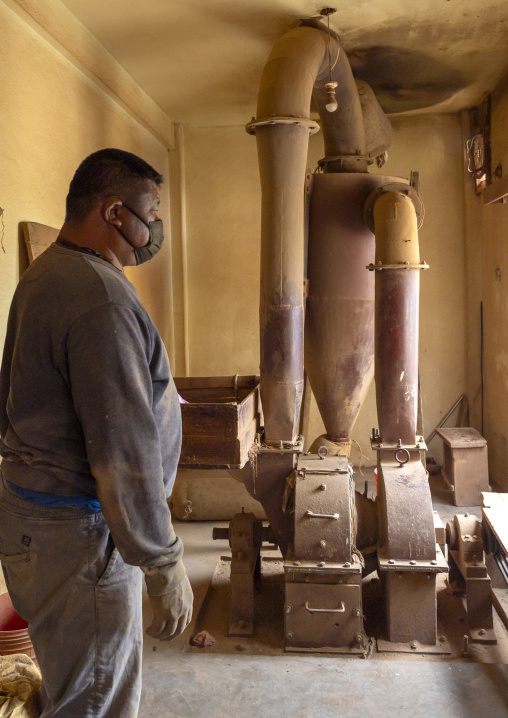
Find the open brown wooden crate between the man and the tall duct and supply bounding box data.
[175,375,260,469]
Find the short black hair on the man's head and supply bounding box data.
[65,147,164,221]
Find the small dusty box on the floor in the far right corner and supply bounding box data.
[437,427,490,506]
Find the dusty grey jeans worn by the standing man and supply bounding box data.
[0,474,143,718]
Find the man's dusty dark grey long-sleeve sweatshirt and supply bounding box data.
[0,244,182,567]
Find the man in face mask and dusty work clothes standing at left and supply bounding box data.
[0,149,192,718]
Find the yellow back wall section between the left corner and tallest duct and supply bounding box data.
[185,126,261,376]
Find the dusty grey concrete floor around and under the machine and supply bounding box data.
[140,477,508,718]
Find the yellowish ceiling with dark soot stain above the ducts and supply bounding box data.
[57,0,508,127]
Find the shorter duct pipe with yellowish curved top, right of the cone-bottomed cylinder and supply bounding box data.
[373,191,426,445]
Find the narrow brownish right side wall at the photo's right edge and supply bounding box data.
[481,71,508,491]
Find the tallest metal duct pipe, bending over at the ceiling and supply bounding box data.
[247,21,365,444]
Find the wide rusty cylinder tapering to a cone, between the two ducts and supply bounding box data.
[305,172,400,455]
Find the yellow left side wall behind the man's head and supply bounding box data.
[0,2,175,358]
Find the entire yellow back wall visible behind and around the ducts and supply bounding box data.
[185,115,464,463]
